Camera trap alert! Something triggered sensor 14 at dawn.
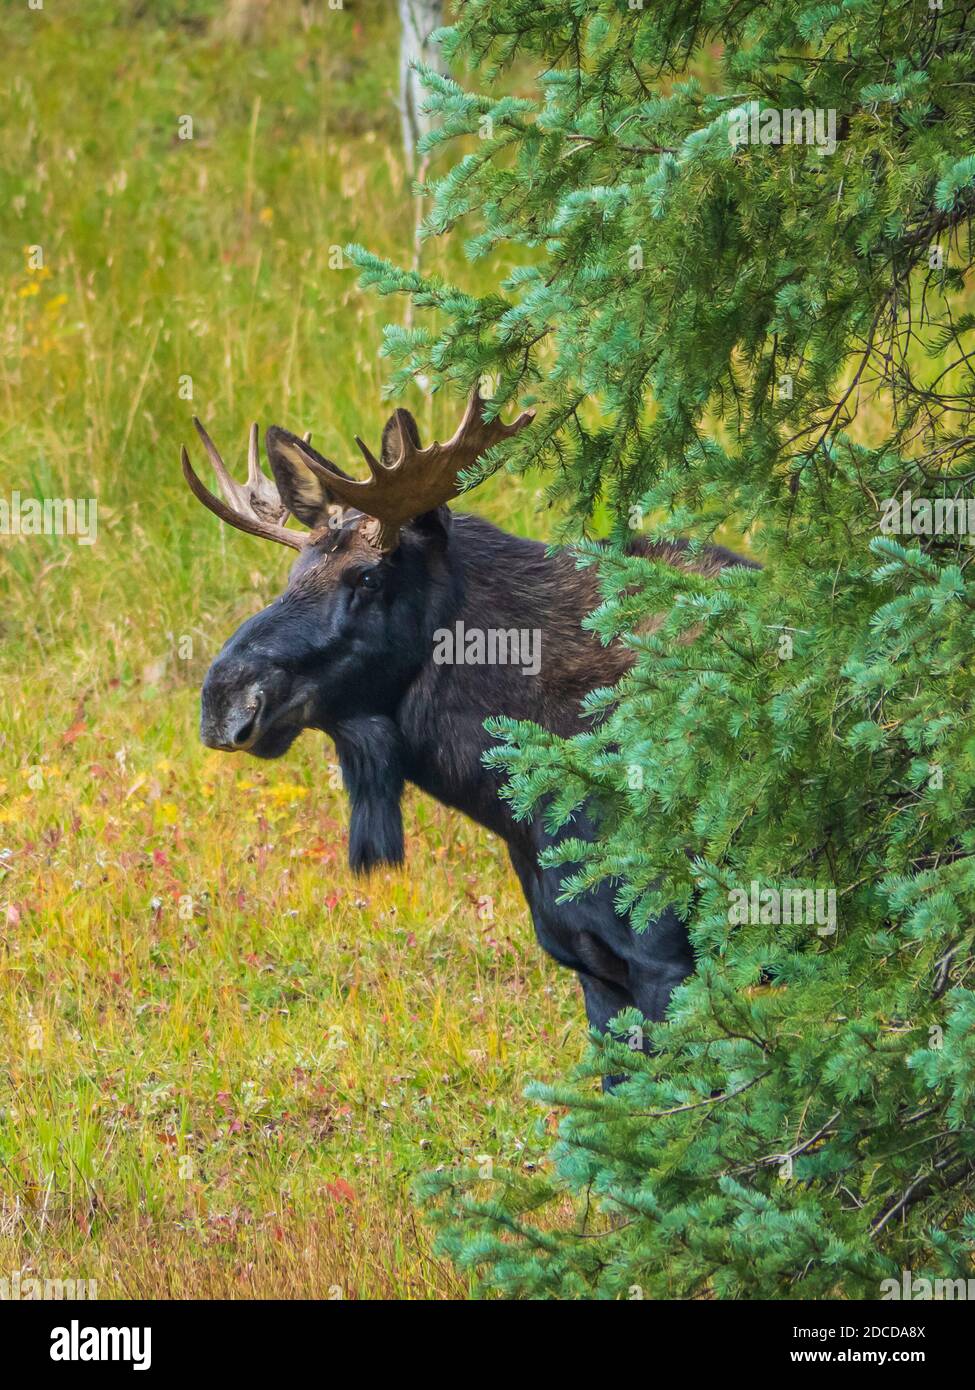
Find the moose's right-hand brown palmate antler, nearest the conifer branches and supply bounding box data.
[289,391,535,550]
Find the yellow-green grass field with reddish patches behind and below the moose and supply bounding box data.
[0,0,584,1298]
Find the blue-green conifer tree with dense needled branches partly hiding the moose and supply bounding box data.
[355,0,975,1298]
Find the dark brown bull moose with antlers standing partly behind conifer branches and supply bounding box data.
[182,393,751,1073]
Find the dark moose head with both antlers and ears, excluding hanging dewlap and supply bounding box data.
[181,392,534,758]
